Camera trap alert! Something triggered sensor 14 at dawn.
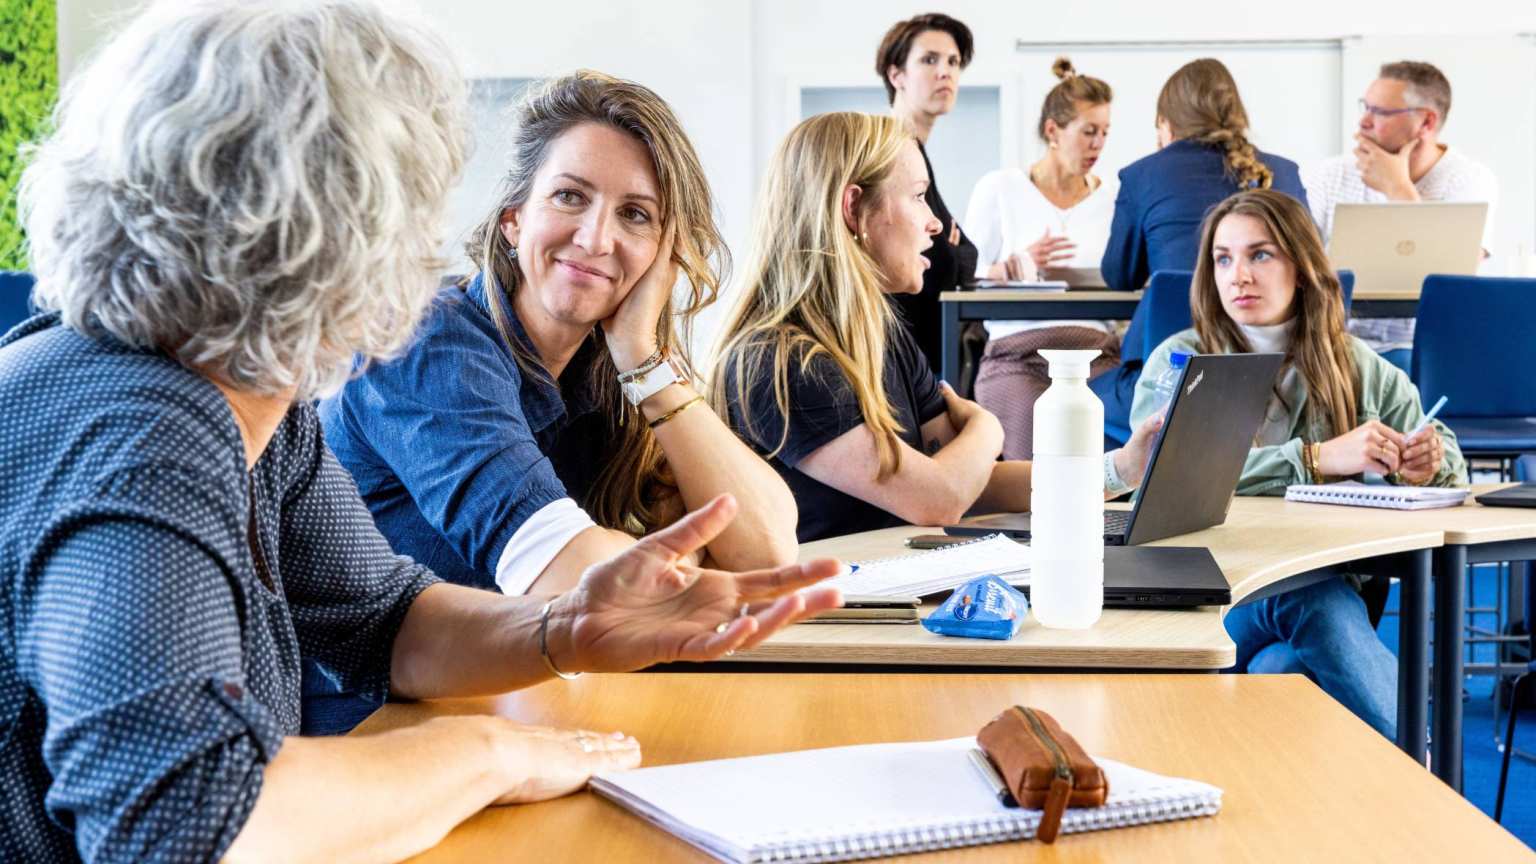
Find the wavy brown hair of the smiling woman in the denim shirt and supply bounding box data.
[465,69,730,533]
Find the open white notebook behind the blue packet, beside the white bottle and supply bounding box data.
[825,533,1029,596]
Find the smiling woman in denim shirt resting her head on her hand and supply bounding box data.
[321,71,796,593]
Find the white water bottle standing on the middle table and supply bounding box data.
[1029,351,1104,630]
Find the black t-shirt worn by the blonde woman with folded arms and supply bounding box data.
[723,326,945,543]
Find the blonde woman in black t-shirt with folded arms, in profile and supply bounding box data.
[710,114,1157,541]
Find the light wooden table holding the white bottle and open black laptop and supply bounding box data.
[733,486,1536,789]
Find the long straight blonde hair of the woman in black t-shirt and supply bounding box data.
[708,112,912,480]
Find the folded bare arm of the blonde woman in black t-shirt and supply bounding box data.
[796,386,1003,524]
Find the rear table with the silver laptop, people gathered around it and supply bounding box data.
[938,289,1419,381]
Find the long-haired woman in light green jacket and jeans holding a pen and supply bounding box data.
[1132,189,1467,738]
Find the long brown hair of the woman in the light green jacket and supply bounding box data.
[1189,189,1359,438]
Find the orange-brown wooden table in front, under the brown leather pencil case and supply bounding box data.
[355,673,1533,864]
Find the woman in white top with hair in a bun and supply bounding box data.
[965,57,1120,460]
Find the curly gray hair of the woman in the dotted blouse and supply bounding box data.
[20,0,467,400]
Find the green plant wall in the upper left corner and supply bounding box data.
[0,0,58,271]
